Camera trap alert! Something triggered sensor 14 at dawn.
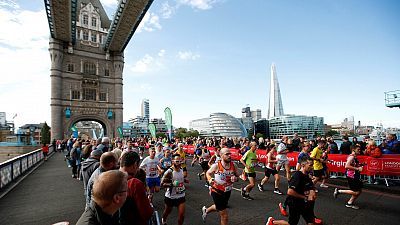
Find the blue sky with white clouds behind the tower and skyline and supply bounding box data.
[0,0,400,128]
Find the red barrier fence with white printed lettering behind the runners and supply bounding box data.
[183,145,400,186]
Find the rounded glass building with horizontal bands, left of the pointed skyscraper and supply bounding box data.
[189,113,247,137]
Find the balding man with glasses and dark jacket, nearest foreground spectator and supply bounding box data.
[76,170,127,225]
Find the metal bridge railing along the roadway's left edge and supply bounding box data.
[0,147,53,191]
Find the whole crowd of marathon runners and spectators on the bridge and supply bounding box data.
[46,134,399,225]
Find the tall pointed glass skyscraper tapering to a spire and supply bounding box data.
[268,63,284,119]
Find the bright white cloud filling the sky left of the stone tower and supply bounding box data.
[0,1,50,127]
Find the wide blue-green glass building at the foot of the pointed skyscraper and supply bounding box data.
[269,115,324,139]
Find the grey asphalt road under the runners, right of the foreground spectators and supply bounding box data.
[154,161,400,225]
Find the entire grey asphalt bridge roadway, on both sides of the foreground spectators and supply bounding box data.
[0,153,400,225]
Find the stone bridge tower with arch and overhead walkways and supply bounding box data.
[44,0,153,139]
